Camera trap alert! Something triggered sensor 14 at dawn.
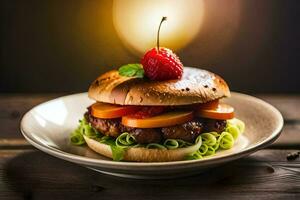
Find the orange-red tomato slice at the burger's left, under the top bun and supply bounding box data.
[91,102,140,119]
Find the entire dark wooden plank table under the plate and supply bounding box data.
[0,94,300,200]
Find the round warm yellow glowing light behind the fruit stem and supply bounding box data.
[113,0,204,53]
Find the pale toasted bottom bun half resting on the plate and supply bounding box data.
[83,136,201,162]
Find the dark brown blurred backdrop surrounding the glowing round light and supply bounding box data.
[0,0,300,93]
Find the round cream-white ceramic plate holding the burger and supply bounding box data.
[21,92,283,178]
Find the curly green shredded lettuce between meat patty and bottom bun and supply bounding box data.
[70,118,245,161]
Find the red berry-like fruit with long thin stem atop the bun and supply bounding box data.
[141,17,183,81]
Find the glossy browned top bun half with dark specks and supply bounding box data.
[88,67,230,106]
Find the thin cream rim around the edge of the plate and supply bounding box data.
[20,92,284,168]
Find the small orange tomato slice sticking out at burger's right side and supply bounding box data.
[196,103,234,120]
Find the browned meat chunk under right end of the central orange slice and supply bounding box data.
[161,120,203,142]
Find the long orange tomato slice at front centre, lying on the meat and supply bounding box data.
[122,111,193,128]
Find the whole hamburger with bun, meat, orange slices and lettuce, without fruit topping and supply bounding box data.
[71,65,244,162]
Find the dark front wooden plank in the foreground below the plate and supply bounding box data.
[0,149,300,199]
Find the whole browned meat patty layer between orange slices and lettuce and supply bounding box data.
[85,112,226,144]
